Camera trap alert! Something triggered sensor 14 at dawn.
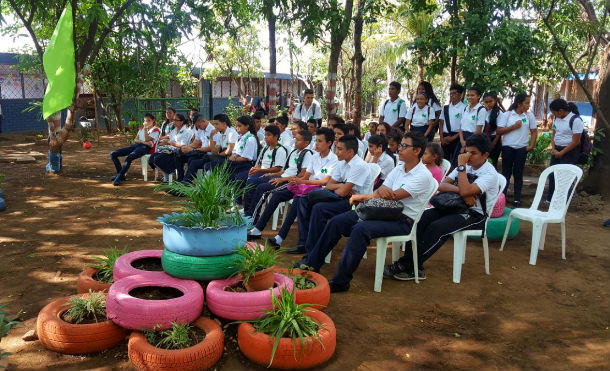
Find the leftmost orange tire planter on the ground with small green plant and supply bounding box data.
[36,291,126,354]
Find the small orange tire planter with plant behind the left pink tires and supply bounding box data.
[77,247,127,294]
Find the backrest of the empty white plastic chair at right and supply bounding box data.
[530,164,582,216]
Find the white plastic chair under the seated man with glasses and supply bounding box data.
[373,180,438,292]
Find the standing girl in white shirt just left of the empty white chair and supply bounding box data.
[497,93,538,207]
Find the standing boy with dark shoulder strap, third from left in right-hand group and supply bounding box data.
[439,84,466,163]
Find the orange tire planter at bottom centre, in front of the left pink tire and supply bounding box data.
[128,317,224,371]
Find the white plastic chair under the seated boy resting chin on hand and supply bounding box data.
[453,173,506,283]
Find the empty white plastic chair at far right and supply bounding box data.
[500,164,582,265]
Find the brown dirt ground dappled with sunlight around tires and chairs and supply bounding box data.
[0,135,610,370]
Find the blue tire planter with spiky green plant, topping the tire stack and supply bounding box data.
[157,164,252,256]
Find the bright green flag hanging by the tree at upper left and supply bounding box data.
[42,1,76,120]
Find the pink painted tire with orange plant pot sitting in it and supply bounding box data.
[206,273,293,321]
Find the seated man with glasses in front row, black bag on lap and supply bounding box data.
[295,133,434,292]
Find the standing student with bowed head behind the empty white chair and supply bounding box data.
[545,99,585,203]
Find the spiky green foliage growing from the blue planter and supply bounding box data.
[155,162,247,228]
